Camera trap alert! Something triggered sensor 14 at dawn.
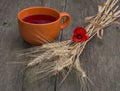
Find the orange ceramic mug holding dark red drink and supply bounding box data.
[18,7,70,45]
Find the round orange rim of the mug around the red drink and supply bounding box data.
[17,6,61,25]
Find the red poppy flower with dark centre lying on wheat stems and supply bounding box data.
[72,27,89,42]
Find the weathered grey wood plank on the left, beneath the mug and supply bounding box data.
[0,0,64,91]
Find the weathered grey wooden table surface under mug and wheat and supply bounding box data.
[0,0,120,91]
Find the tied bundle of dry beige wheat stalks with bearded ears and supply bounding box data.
[19,0,120,87]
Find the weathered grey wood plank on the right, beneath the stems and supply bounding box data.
[59,0,120,91]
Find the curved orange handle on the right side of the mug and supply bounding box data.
[60,12,70,29]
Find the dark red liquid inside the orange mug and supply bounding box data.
[23,15,57,24]
